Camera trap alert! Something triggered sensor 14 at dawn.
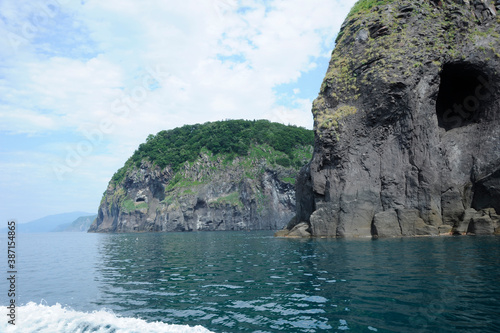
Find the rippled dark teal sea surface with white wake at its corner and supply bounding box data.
[0,232,500,333]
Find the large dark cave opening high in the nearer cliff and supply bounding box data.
[436,62,493,131]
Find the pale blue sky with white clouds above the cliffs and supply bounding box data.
[0,0,356,225]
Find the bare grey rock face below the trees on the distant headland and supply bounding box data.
[89,152,302,232]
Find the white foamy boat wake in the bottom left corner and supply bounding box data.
[0,302,210,333]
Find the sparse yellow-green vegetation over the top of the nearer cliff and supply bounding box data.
[312,0,500,140]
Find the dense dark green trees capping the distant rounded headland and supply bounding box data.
[112,120,314,184]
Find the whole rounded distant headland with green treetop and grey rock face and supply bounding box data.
[89,121,313,232]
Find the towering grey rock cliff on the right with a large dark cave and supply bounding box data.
[287,0,500,237]
